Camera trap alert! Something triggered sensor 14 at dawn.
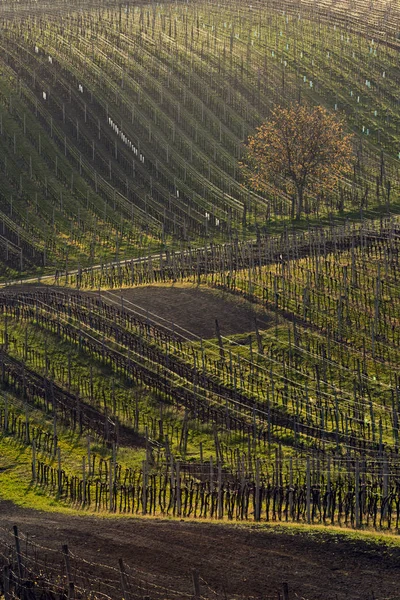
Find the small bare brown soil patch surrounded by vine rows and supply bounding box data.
[105,286,271,339]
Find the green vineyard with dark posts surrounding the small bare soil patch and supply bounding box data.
[0,219,400,530]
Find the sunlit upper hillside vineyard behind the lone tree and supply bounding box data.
[0,0,400,278]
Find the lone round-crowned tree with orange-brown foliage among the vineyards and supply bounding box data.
[241,104,353,219]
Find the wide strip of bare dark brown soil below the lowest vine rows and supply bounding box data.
[0,502,400,600]
